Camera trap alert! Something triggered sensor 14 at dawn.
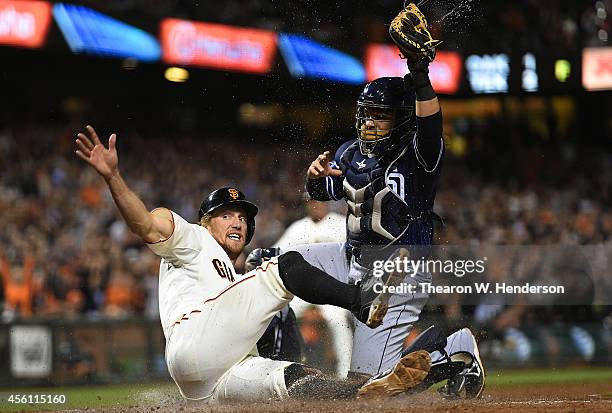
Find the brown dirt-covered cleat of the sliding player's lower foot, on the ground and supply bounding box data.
[357,350,431,398]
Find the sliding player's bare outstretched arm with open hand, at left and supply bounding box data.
[76,125,174,243]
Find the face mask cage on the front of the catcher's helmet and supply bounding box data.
[355,104,410,157]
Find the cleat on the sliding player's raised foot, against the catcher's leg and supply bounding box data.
[353,248,409,328]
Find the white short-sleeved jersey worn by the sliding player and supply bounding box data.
[148,212,236,338]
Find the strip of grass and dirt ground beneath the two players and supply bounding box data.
[13,376,612,413]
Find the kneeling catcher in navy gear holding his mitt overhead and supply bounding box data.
[247,3,485,397]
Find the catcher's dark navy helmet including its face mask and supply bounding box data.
[355,77,415,156]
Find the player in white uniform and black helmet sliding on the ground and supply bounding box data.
[76,126,431,403]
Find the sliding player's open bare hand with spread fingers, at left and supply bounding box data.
[76,125,119,179]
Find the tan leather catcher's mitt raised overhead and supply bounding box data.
[389,3,440,63]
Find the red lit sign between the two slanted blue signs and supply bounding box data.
[160,19,276,73]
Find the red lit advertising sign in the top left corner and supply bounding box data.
[0,0,51,48]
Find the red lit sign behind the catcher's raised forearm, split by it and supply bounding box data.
[365,44,461,94]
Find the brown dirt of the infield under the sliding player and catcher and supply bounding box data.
[118,383,612,413]
